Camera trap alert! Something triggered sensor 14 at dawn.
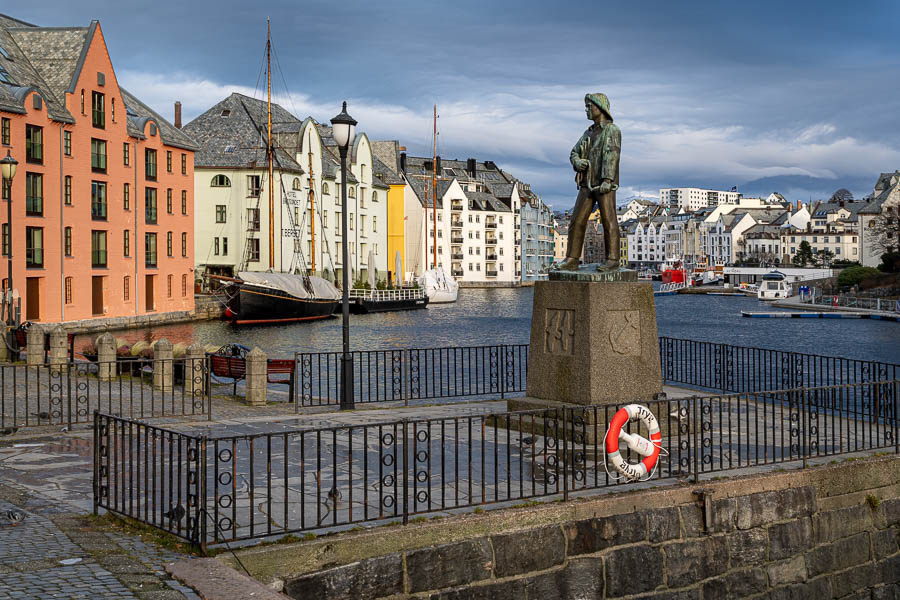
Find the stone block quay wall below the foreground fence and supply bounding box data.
[241,457,900,600]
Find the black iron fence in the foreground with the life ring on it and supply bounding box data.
[94,380,900,544]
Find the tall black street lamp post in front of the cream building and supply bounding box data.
[331,101,356,410]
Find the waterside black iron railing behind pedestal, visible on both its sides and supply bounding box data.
[295,337,900,409]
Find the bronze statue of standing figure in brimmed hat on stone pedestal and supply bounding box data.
[555,94,622,271]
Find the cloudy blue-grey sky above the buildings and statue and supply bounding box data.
[14,0,900,209]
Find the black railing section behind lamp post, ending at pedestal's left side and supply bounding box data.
[296,344,528,408]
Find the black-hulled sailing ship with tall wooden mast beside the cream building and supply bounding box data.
[218,20,341,325]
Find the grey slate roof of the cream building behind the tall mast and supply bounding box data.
[184,92,305,173]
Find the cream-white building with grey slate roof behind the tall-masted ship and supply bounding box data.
[184,93,388,280]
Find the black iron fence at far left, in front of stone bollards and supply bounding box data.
[0,357,211,431]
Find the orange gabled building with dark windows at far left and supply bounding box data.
[0,15,196,322]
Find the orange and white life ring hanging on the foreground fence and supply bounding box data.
[606,404,662,481]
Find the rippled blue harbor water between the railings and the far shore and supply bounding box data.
[79,287,900,363]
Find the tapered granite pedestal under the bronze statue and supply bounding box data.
[527,268,662,405]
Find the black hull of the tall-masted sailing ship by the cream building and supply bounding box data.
[226,283,340,325]
